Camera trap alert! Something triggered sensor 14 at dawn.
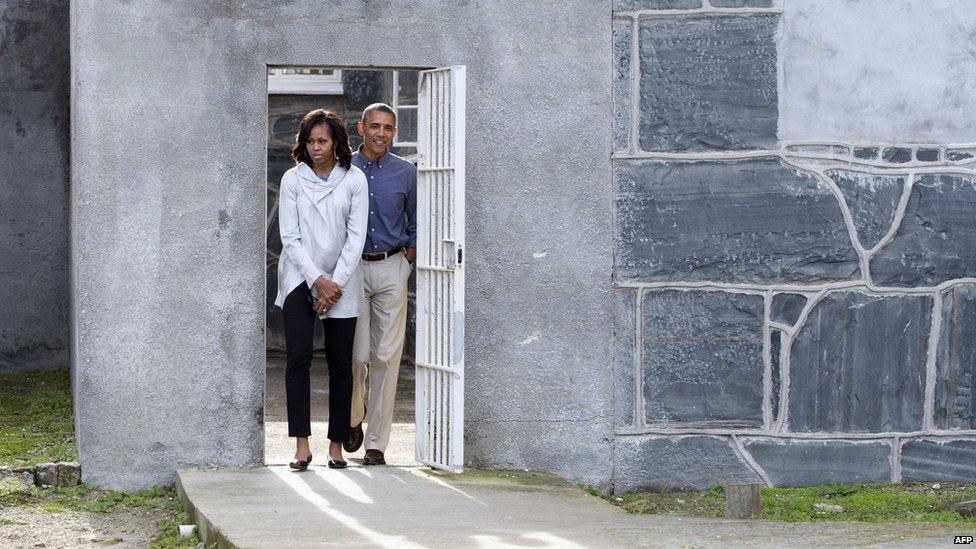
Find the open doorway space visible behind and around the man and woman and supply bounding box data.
[264,66,418,465]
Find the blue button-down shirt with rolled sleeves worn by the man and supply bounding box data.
[352,149,417,253]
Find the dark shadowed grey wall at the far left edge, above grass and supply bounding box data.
[0,0,69,372]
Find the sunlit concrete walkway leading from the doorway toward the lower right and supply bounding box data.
[177,461,960,549]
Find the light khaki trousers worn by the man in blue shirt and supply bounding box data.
[350,252,410,452]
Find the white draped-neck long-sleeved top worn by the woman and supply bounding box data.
[275,163,369,318]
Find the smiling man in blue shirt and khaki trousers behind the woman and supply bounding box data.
[345,103,417,465]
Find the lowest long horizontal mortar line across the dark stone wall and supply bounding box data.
[614,426,976,443]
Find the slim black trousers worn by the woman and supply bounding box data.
[282,283,356,442]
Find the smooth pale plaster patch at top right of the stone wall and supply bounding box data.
[779,0,976,143]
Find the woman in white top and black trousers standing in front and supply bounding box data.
[275,109,369,471]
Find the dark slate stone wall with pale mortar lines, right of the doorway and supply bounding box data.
[612,0,976,492]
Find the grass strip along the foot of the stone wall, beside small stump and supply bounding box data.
[610,484,976,524]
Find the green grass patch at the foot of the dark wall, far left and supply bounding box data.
[0,370,78,467]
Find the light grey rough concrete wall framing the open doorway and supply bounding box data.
[71,0,612,487]
